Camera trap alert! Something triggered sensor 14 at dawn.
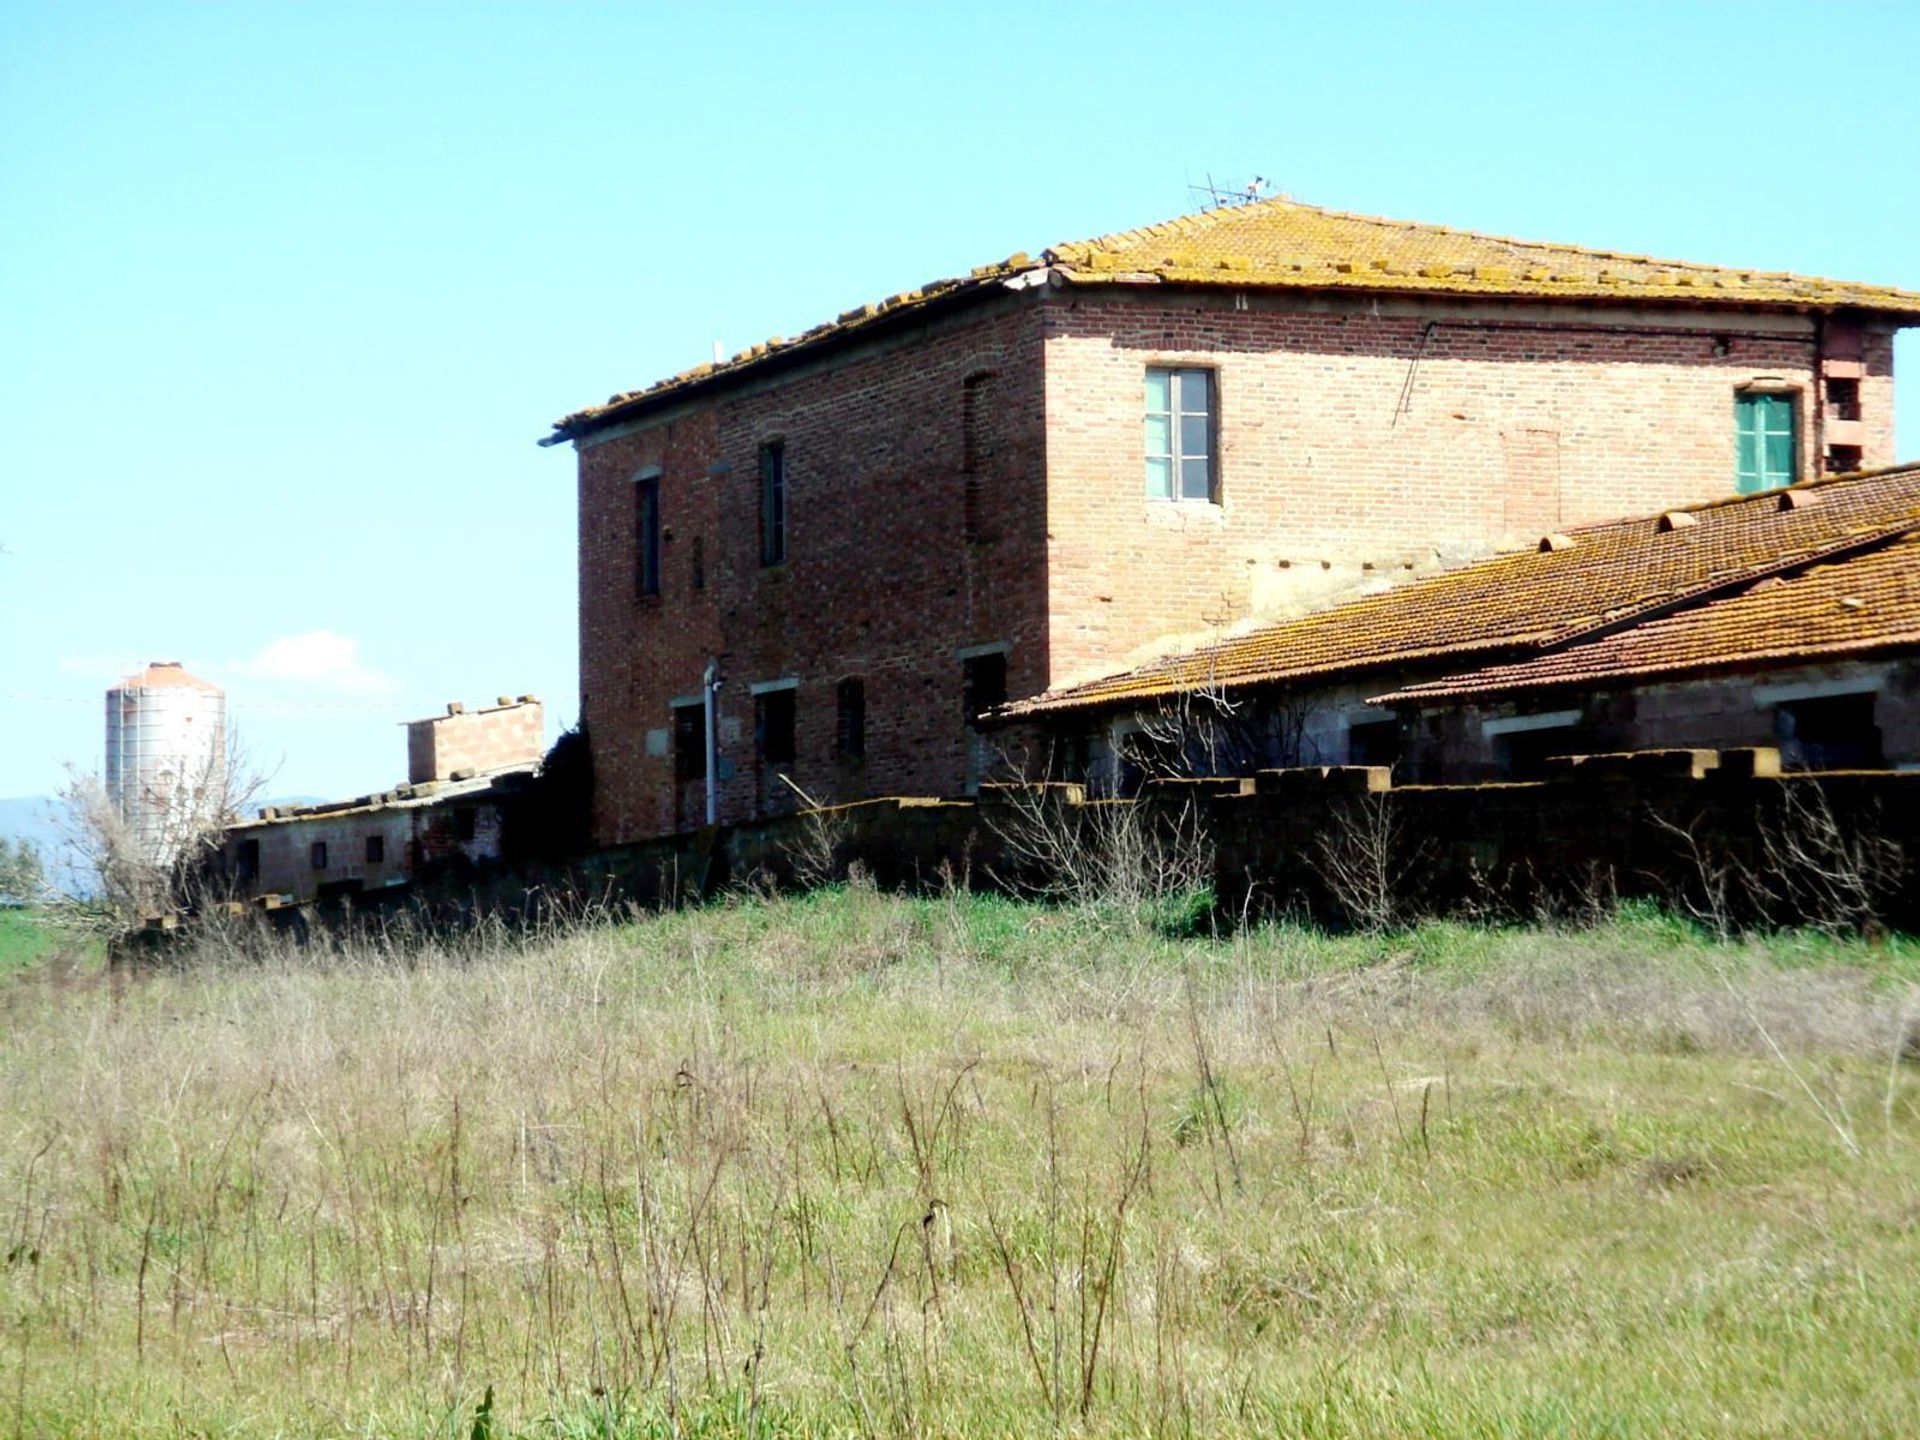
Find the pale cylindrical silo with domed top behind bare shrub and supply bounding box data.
[106,660,227,864]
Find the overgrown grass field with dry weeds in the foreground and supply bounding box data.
[0,889,1920,1440]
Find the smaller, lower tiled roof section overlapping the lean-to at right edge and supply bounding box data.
[1377,516,1920,705]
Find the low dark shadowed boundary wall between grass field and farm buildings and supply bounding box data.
[552,747,1920,929]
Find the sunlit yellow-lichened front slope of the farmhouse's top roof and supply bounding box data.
[1046,200,1920,315]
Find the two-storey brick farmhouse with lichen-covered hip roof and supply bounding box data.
[545,200,1920,843]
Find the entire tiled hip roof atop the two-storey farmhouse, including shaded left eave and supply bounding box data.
[545,200,1920,444]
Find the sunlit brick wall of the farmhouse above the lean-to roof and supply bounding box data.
[1046,290,1893,684]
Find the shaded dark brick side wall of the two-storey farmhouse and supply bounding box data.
[580,300,1048,843]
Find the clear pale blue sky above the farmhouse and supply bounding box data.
[0,0,1920,795]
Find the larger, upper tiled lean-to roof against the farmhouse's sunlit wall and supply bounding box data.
[1000,465,1920,718]
